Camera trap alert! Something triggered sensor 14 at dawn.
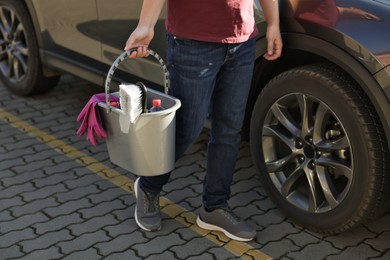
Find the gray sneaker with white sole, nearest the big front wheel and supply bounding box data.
[196,207,256,241]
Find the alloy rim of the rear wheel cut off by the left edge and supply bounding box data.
[0,6,28,83]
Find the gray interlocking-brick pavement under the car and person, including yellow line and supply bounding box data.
[0,76,390,260]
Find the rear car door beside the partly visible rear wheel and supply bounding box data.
[33,0,101,67]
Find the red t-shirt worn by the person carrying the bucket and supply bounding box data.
[166,0,257,43]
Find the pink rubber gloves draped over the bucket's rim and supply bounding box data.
[76,93,119,146]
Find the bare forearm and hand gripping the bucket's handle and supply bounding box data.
[124,0,165,58]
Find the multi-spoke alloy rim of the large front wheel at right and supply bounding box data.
[262,93,353,213]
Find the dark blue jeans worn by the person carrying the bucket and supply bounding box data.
[140,34,255,210]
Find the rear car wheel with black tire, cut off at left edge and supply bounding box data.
[0,0,59,96]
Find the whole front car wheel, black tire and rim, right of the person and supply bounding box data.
[250,64,390,234]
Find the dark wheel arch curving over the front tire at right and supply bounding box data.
[244,33,390,154]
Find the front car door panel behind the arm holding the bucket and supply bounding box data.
[97,0,166,87]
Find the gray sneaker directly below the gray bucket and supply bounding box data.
[134,178,161,231]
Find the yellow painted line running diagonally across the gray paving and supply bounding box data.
[0,108,272,260]
